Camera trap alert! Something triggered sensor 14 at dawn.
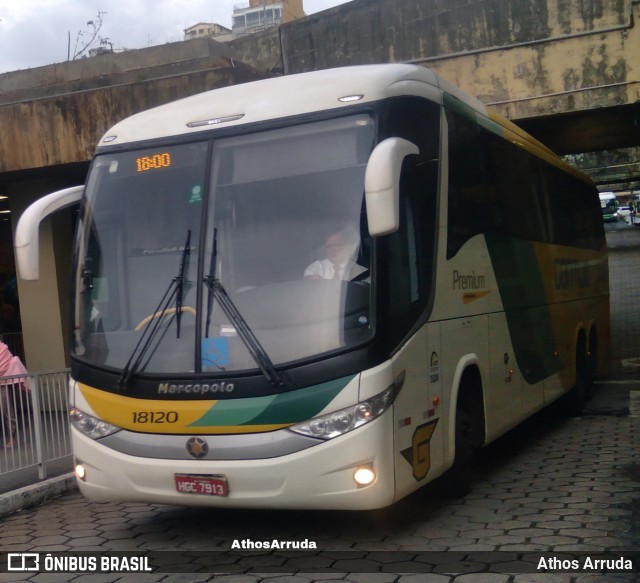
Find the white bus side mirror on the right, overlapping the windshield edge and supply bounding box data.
[364,138,420,237]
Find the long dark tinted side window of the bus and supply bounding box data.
[447,111,602,258]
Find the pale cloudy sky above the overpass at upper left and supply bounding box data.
[0,0,350,73]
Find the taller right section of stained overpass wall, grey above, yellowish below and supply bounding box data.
[232,0,640,119]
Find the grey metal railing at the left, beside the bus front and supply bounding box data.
[0,369,72,491]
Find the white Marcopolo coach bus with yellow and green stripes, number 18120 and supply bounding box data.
[16,65,609,509]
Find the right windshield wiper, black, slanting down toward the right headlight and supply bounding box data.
[203,229,284,387]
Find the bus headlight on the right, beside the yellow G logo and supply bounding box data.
[289,385,396,439]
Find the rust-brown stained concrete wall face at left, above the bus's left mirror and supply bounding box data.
[0,56,261,172]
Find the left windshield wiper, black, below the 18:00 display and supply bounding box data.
[118,229,191,391]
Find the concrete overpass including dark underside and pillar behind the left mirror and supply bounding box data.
[0,0,640,370]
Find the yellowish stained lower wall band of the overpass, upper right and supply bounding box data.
[412,0,640,119]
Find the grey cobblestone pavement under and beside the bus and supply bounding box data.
[0,229,640,583]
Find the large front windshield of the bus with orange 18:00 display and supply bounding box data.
[73,115,375,374]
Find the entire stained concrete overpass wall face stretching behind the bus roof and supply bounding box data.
[0,0,640,173]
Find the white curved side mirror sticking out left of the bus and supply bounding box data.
[14,186,84,280]
